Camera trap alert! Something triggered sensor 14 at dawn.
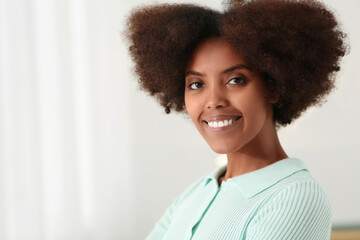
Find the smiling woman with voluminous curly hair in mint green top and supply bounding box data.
[127,0,346,240]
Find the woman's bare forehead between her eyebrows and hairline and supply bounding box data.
[186,37,250,71]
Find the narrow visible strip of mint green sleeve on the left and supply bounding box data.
[145,174,204,240]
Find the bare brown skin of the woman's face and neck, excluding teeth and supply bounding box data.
[185,38,288,185]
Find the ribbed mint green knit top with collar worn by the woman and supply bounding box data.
[146,158,332,240]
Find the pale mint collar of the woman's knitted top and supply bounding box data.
[203,158,309,198]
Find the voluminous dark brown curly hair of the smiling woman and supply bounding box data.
[126,0,347,127]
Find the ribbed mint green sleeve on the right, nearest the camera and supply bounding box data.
[246,180,332,240]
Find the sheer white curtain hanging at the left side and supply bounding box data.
[0,0,132,240]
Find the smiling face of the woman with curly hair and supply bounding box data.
[185,38,274,154]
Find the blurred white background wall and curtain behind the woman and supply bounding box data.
[0,0,360,240]
